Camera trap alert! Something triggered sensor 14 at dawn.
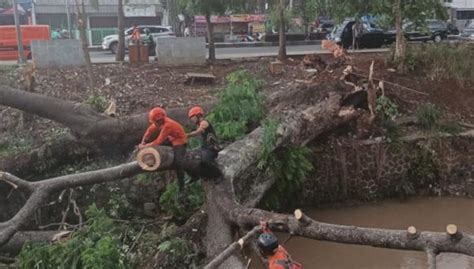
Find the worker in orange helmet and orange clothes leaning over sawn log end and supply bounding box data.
[138,107,187,193]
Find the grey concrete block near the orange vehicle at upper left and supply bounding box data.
[31,39,86,68]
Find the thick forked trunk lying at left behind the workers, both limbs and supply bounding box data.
[0,85,212,176]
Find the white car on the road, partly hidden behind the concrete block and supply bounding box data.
[102,25,176,54]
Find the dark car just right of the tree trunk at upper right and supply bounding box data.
[385,20,449,44]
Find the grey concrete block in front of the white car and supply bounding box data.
[156,37,206,65]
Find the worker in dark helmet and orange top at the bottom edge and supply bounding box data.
[257,222,303,269]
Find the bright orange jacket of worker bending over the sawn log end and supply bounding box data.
[143,117,188,146]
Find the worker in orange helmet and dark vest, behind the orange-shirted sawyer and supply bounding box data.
[186,106,221,161]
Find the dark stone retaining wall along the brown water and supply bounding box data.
[299,132,474,205]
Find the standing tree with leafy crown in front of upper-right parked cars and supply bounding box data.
[333,0,447,72]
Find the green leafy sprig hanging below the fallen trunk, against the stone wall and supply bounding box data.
[263,147,314,210]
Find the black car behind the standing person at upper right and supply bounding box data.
[328,20,385,49]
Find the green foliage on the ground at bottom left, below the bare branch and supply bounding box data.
[18,205,130,269]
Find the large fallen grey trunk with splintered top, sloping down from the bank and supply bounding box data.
[207,91,357,268]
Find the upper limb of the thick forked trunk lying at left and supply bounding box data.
[0,85,212,148]
